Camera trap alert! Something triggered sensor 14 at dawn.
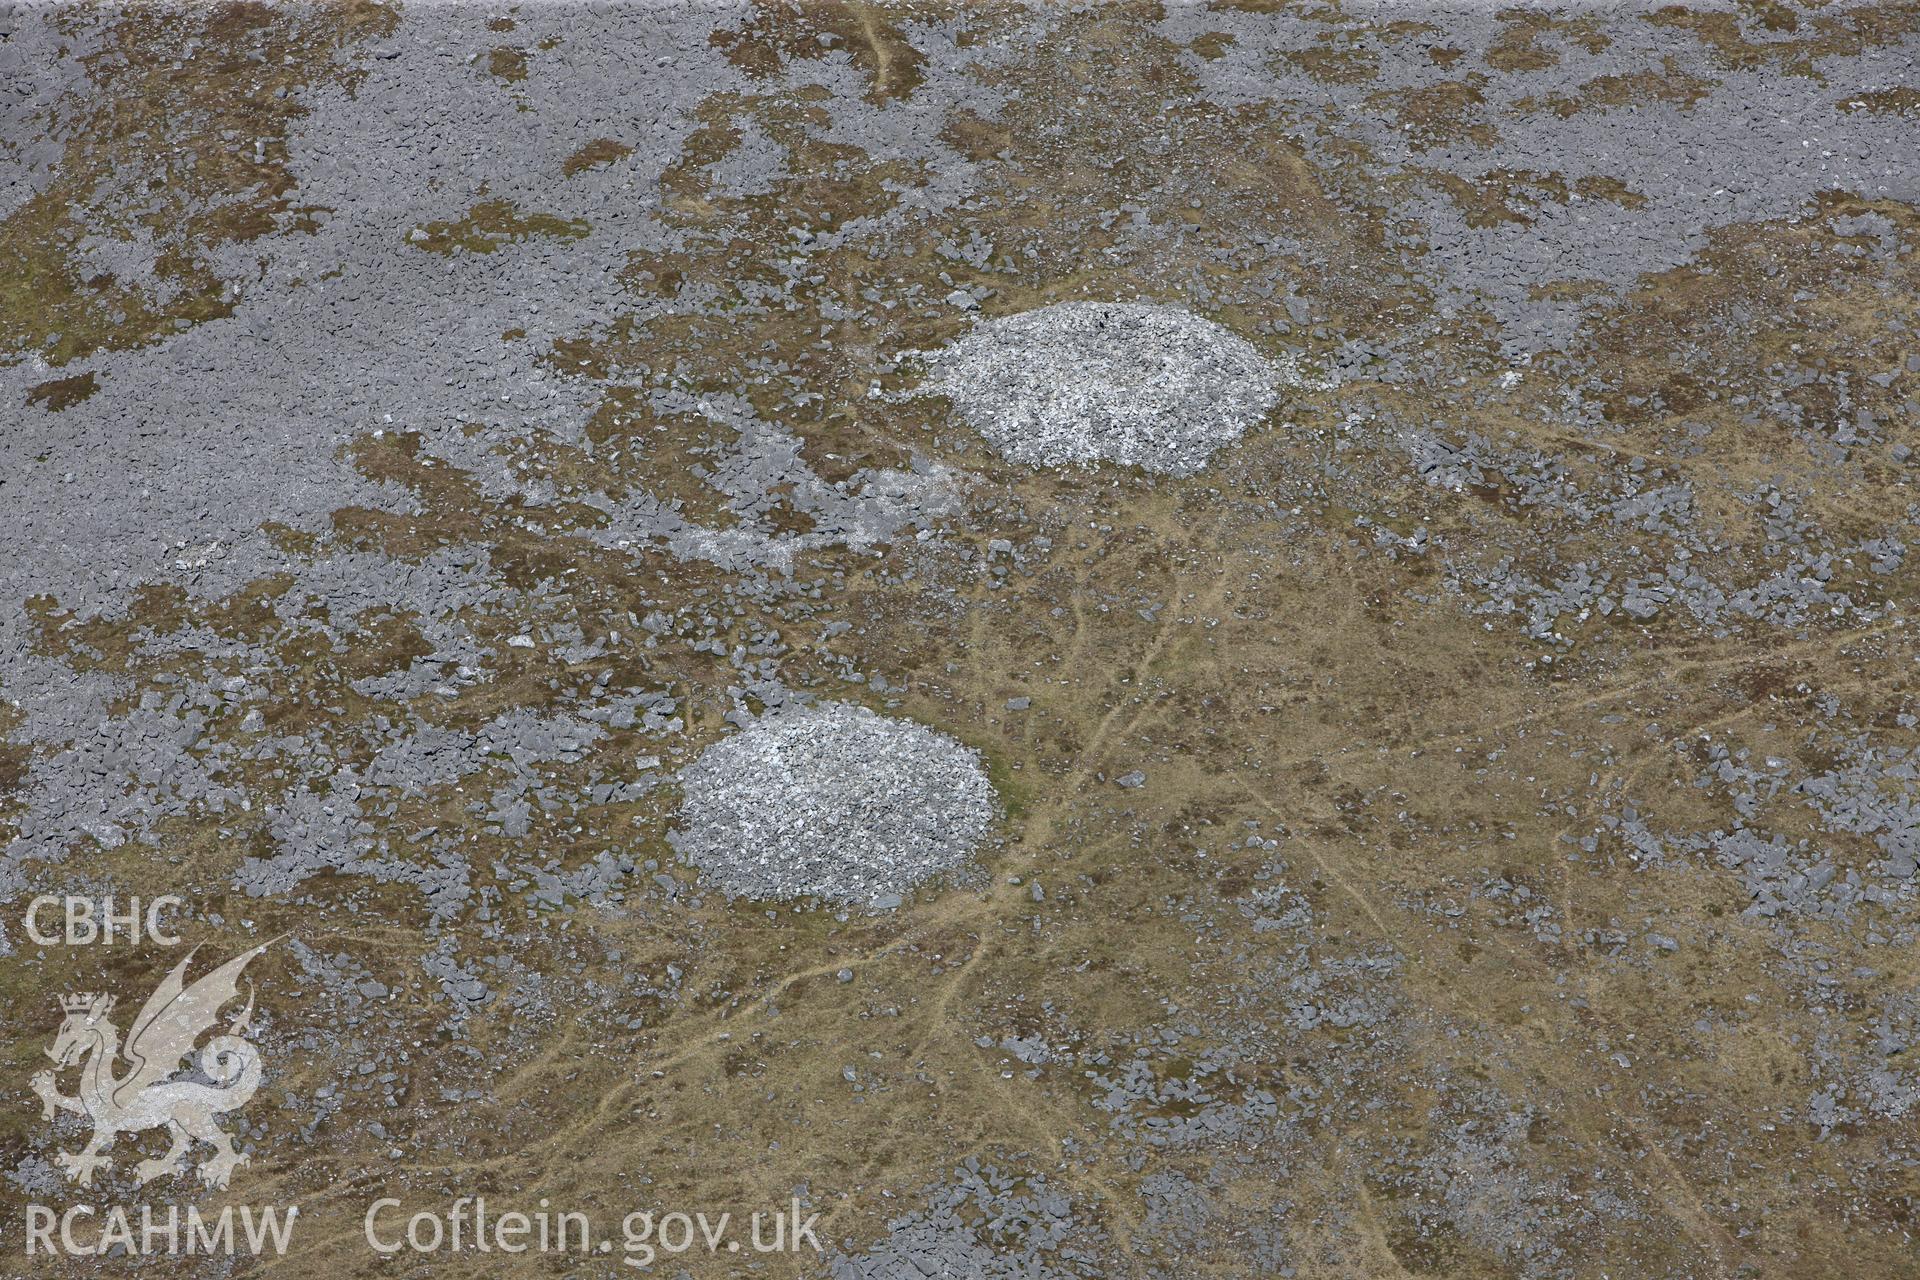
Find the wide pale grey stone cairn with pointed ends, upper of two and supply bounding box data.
[925,301,1300,476]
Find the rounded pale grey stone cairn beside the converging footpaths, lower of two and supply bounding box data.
[670,702,995,906]
